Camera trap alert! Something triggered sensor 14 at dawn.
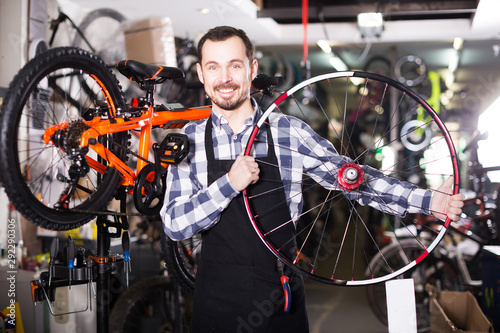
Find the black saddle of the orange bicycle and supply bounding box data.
[116,60,184,84]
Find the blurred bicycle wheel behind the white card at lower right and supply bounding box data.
[366,239,463,332]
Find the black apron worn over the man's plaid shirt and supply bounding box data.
[191,118,309,333]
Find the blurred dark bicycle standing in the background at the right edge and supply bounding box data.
[366,129,500,332]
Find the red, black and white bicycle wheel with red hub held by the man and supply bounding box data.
[244,72,459,285]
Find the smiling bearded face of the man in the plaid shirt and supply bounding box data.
[197,37,257,110]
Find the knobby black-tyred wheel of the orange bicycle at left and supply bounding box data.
[0,48,127,230]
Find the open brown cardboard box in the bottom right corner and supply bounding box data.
[426,285,494,333]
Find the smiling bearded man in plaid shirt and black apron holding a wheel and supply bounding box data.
[161,26,463,333]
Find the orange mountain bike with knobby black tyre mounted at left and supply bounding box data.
[1,48,210,230]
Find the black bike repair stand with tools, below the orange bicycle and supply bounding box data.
[31,192,130,333]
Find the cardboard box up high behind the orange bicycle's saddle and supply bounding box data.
[122,17,177,67]
